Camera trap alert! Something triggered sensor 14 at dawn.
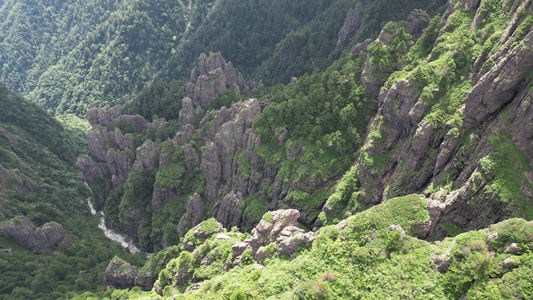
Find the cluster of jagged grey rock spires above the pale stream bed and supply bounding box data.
[77,53,275,251]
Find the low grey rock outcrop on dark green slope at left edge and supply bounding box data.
[0,217,72,254]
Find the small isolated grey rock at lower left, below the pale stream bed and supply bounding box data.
[104,256,139,289]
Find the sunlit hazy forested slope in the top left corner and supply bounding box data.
[0,0,213,116]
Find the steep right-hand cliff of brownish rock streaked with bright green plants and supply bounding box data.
[324,1,533,237]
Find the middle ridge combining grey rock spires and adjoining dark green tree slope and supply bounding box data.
[78,48,378,251]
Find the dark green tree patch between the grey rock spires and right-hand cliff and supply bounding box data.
[253,55,373,205]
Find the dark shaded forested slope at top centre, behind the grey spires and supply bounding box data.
[159,0,445,85]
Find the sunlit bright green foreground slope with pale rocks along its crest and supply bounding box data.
[82,195,533,299]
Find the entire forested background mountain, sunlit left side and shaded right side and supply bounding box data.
[0,0,444,116]
